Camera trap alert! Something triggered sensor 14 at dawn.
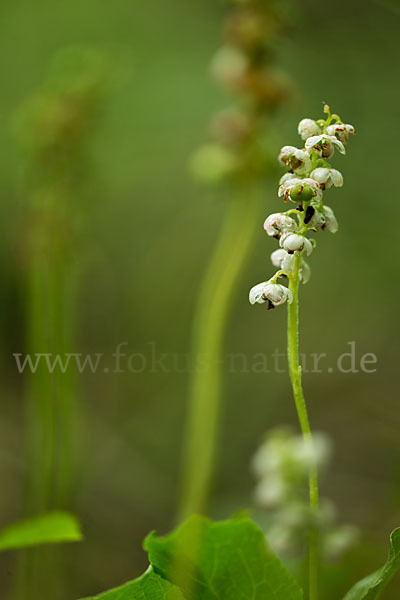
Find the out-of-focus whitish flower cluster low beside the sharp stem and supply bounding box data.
[252,428,357,559]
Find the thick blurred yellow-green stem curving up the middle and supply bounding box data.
[178,188,259,520]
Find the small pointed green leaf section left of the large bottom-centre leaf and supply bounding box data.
[86,567,184,600]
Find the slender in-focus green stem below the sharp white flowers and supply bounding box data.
[288,254,319,600]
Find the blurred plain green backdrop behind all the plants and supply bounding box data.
[0,0,400,600]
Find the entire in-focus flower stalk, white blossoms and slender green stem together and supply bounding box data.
[249,105,355,600]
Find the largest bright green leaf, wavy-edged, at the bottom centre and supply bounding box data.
[144,516,303,600]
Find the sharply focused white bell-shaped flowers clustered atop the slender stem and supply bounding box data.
[249,105,355,308]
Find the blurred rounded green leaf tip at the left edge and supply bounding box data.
[0,511,82,551]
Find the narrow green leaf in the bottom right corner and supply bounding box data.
[344,527,400,600]
